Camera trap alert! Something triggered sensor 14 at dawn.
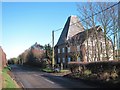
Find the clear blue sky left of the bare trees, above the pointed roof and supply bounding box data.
[2,2,78,58]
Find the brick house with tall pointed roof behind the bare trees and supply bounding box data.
[55,16,113,68]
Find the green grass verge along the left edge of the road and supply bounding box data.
[2,68,16,88]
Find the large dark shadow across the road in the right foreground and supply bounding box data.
[42,74,95,89]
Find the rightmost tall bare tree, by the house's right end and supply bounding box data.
[98,2,116,60]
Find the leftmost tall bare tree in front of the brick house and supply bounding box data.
[77,3,100,61]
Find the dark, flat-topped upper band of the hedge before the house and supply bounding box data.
[68,61,120,73]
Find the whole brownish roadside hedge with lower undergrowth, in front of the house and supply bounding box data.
[69,61,120,85]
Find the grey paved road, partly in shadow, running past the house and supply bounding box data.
[11,65,94,89]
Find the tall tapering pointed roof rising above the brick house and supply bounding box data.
[56,16,84,46]
